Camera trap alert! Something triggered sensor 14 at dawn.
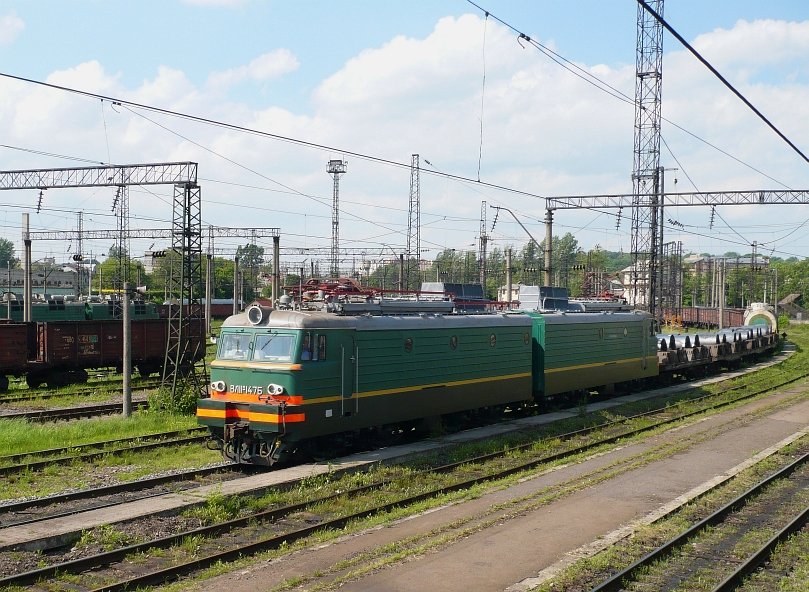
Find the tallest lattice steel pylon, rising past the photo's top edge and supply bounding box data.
[630,0,663,316]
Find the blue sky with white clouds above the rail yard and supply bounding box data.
[0,0,809,267]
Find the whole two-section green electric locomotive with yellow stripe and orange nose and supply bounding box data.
[197,303,657,465]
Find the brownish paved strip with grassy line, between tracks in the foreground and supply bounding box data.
[183,384,809,592]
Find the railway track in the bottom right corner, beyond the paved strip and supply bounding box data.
[592,453,809,592]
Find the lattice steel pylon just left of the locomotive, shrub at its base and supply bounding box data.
[163,183,207,400]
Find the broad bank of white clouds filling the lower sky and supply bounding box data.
[0,16,809,260]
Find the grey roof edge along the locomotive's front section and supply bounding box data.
[222,310,531,330]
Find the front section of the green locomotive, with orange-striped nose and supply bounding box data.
[197,307,532,465]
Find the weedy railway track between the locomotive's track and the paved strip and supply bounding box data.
[0,364,794,590]
